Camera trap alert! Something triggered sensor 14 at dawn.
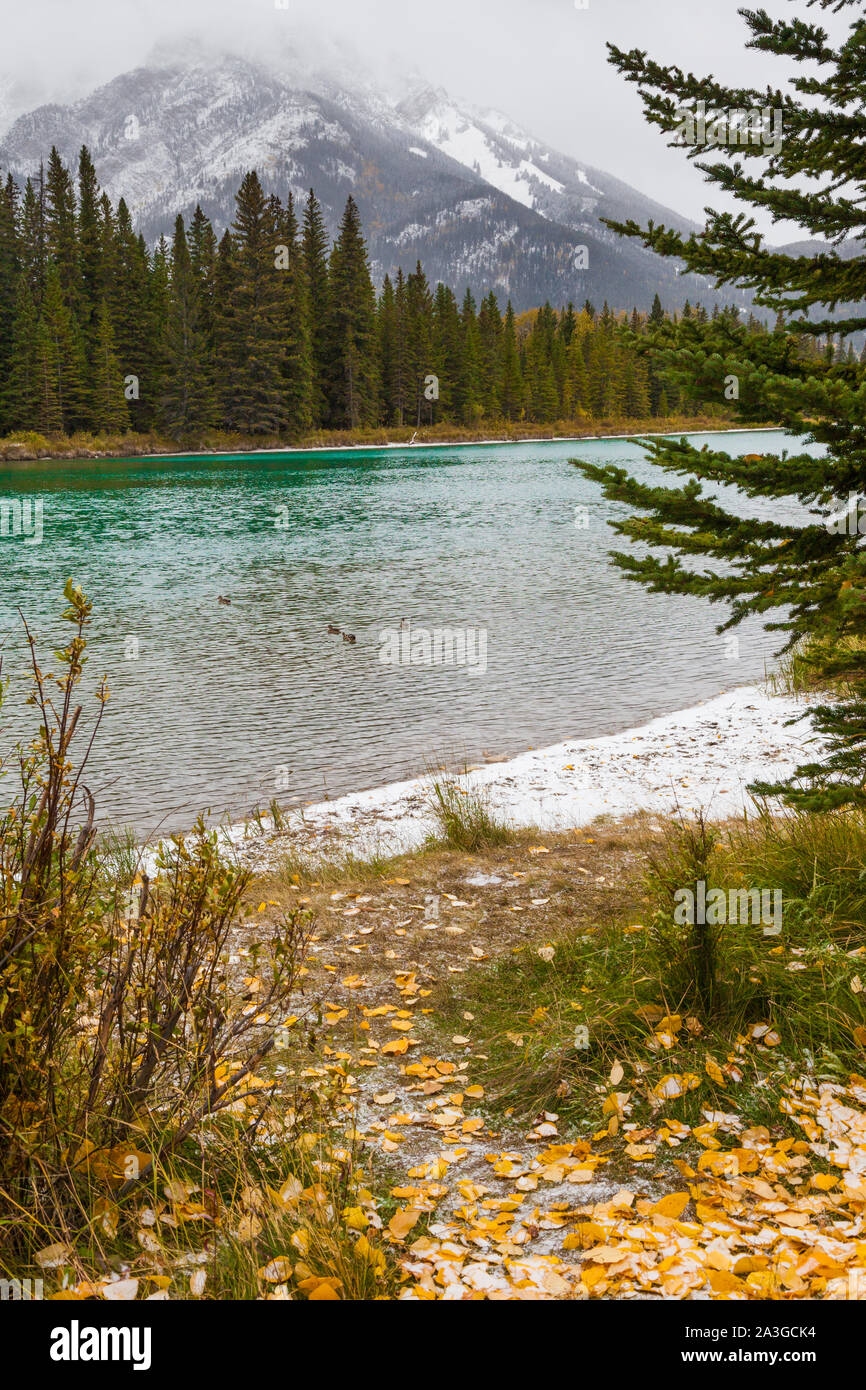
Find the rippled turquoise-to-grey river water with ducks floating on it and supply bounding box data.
[0,432,811,833]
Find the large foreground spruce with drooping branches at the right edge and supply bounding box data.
[578,0,866,809]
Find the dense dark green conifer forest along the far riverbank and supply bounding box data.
[0,147,834,438]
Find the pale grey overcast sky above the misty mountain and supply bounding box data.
[0,0,838,230]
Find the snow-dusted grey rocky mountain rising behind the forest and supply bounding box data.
[0,57,714,310]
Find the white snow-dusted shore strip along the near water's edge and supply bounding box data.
[215,685,817,869]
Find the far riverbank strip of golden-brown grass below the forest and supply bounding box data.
[0,414,777,463]
